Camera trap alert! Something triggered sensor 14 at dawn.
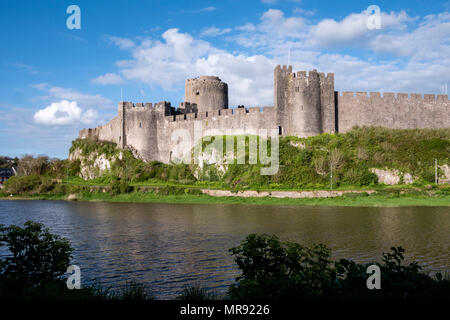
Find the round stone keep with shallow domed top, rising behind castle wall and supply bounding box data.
[184,76,228,112]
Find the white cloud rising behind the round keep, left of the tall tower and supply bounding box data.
[111,29,274,105]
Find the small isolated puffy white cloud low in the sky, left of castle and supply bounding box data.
[34,100,98,126]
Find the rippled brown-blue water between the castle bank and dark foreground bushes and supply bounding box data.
[0,200,450,299]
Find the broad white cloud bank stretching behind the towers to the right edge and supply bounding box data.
[92,9,450,106]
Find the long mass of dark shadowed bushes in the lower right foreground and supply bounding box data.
[228,234,450,300]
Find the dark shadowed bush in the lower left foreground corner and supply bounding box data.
[0,221,152,300]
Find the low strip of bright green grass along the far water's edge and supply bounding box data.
[0,191,450,207]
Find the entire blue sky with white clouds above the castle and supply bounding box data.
[0,0,450,158]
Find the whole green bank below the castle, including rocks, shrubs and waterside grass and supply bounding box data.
[0,127,450,206]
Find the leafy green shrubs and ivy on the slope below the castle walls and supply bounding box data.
[5,127,450,195]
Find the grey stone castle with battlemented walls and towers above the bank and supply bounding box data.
[79,66,450,163]
